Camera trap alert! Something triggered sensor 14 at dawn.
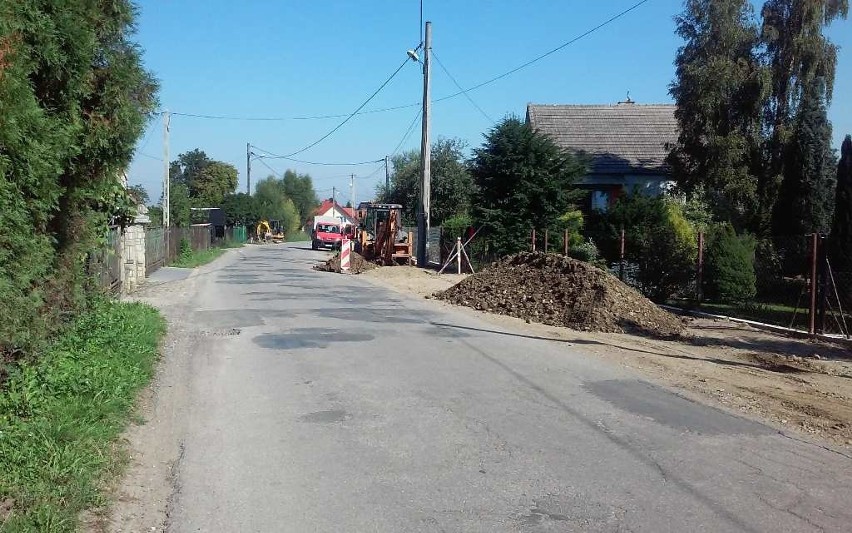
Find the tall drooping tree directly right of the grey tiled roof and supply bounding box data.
[669,0,768,227]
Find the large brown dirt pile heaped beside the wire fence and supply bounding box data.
[435,252,684,337]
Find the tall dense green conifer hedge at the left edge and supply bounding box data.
[0,0,157,358]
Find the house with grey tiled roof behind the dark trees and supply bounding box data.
[526,102,679,209]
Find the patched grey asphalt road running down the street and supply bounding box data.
[136,245,852,532]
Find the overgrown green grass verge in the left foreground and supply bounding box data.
[0,301,165,532]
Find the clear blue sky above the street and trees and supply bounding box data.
[129,0,852,202]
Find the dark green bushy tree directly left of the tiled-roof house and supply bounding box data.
[471,117,586,254]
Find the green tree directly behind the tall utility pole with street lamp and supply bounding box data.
[378,138,473,226]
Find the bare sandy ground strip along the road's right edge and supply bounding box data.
[361,267,852,449]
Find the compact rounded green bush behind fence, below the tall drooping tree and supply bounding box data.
[704,223,757,303]
